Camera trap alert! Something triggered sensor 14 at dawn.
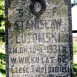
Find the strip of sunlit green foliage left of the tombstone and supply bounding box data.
[0,0,6,77]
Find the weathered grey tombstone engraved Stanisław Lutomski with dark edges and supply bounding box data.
[6,0,73,77]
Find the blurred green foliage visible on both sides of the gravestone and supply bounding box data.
[0,0,77,77]
